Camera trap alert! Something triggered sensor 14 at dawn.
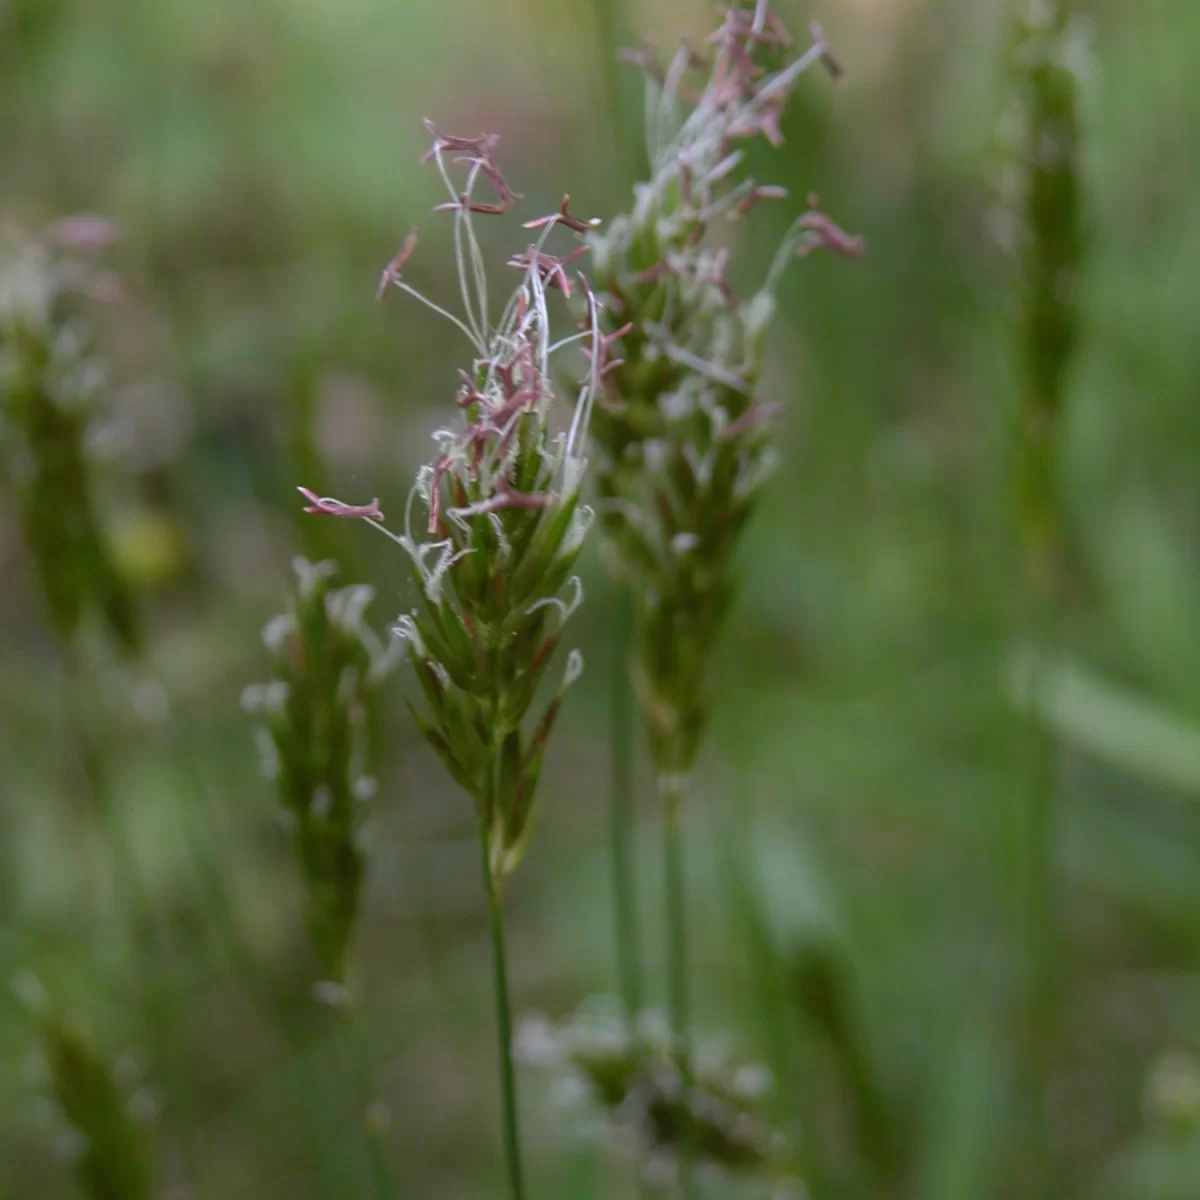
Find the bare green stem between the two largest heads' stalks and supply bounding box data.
[608,588,642,1032]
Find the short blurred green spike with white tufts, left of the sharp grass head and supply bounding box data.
[242,558,389,985]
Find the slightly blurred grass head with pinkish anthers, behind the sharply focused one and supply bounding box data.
[590,0,864,773]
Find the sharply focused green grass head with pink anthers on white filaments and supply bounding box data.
[300,122,606,878]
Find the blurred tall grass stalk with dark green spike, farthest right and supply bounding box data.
[1001,0,1084,1198]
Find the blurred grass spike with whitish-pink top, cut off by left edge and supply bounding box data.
[0,217,138,650]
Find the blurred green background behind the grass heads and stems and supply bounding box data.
[0,0,1200,1200]
